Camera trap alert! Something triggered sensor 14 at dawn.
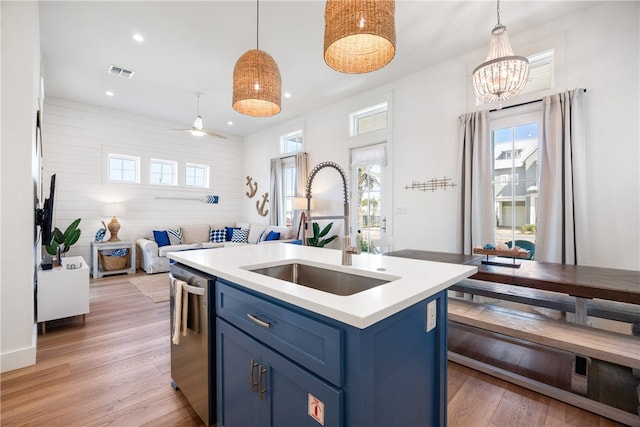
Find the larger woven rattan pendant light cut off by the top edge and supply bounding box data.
[324,0,396,74]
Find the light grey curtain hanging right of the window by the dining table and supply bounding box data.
[536,89,591,264]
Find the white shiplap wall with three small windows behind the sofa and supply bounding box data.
[42,98,245,262]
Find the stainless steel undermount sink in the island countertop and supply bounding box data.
[247,262,399,296]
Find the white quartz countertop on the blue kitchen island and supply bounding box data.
[168,243,477,329]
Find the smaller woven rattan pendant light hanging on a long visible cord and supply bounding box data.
[233,1,282,117]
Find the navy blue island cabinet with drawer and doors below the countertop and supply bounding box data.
[216,279,447,427]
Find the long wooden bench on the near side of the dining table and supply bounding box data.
[448,298,640,426]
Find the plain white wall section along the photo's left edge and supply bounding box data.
[0,2,40,372]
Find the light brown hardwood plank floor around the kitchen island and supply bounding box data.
[0,273,619,427]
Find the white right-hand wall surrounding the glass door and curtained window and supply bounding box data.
[243,2,640,269]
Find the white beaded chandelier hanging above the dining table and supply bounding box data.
[472,0,529,102]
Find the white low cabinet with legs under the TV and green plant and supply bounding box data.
[37,256,89,334]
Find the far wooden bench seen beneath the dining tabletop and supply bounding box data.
[449,280,640,324]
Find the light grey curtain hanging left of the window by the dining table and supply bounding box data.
[458,111,496,254]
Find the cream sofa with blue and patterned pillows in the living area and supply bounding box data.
[136,222,293,274]
